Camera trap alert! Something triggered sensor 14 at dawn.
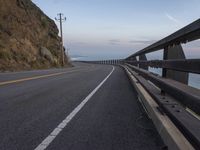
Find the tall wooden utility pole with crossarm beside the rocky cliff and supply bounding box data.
[55,13,67,66]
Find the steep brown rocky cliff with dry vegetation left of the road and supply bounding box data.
[0,0,67,70]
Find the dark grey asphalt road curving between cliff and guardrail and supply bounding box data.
[0,64,163,150]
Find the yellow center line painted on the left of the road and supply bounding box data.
[0,70,79,86]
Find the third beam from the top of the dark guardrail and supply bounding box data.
[127,64,200,114]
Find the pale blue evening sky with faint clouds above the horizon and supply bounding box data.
[32,0,200,60]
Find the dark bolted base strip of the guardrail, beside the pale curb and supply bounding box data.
[126,68,200,149]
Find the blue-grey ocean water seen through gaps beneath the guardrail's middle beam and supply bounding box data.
[149,67,200,89]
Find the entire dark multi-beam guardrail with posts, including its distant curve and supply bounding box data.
[87,19,200,149]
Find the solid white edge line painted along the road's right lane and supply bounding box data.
[35,67,115,150]
